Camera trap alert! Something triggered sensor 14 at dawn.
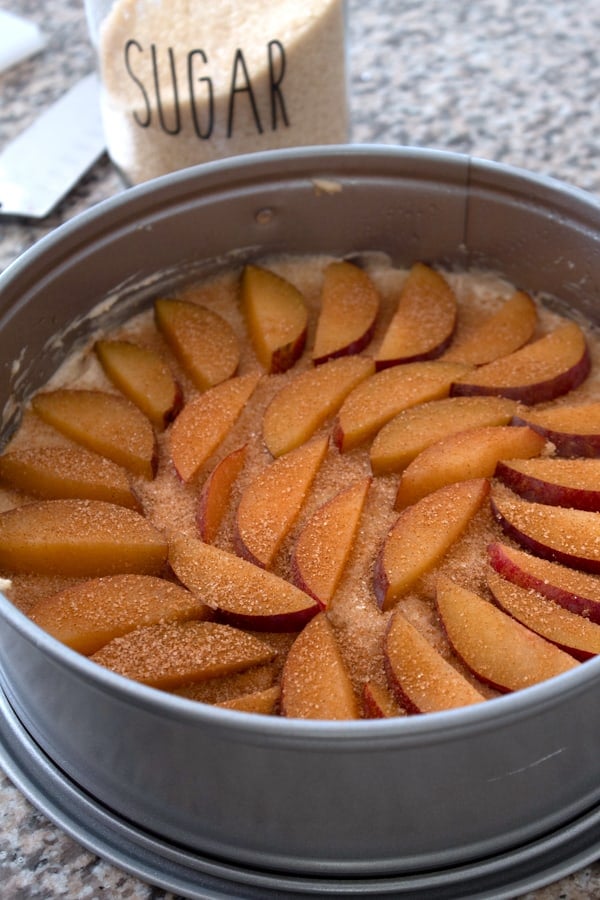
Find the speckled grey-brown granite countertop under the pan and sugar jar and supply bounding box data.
[0,0,600,900]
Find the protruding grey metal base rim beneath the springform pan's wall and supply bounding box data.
[0,692,600,900]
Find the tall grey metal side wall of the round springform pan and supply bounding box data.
[0,146,600,881]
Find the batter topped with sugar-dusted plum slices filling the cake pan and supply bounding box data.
[0,255,600,720]
